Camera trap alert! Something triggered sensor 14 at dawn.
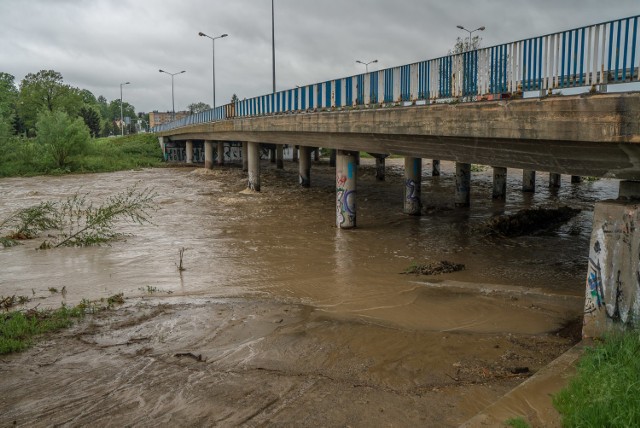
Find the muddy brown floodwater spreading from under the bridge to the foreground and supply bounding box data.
[0,159,617,426]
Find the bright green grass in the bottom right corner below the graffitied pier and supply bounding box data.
[553,331,640,427]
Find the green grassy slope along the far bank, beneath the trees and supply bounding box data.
[0,134,163,177]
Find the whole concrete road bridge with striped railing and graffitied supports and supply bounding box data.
[153,16,640,335]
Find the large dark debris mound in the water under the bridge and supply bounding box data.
[485,206,580,237]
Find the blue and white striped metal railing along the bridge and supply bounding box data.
[152,15,640,132]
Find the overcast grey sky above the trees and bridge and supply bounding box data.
[0,0,640,112]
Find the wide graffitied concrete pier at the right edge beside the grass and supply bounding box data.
[582,181,640,337]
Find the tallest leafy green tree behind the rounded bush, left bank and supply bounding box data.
[18,70,83,130]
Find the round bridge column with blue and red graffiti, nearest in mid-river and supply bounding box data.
[336,150,358,229]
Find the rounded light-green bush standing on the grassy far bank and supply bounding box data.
[36,110,91,168]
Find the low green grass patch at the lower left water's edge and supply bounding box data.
[0,306,84,355]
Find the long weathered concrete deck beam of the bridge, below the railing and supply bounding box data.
[159,93,640,180]
